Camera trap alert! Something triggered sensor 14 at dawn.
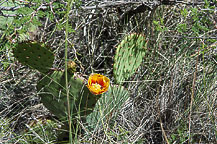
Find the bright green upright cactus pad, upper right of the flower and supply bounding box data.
[114,34,147,84]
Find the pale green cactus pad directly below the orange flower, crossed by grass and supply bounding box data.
[86,86,129,131]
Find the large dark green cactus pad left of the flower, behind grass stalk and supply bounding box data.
[37,71,101,121]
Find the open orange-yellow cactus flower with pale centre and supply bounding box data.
[87,74,110,95]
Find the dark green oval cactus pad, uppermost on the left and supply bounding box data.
[13,42,54,73]
